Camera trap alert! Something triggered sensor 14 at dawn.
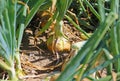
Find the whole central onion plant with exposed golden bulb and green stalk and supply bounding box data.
[36,0,72,58]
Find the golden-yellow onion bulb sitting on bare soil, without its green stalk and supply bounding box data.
[47,36,71,52]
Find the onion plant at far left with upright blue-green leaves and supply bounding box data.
[0,0,45,81]
